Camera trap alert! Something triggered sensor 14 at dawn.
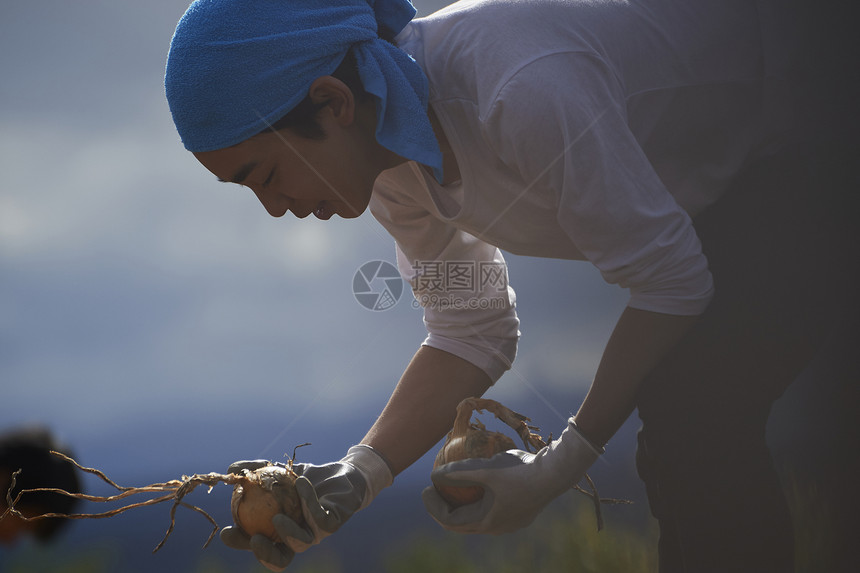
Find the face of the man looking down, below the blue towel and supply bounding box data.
[194,119,379,220]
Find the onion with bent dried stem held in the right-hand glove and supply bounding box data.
[433,398,632,531]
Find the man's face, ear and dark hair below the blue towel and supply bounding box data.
[194,58,403,220]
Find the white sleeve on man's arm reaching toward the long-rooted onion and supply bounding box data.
[371,172,520,382]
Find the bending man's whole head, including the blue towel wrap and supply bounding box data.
[165,0,442,194]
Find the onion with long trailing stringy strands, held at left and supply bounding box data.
[0,444,306,553]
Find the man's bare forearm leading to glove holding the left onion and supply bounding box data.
[362,346,491,475]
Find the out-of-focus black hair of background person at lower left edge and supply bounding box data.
[0,426,81,542]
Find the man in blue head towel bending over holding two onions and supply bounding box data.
[166,0,853,573]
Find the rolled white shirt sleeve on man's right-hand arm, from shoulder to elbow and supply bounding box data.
[484,53,713,315]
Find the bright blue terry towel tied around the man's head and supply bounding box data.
[164,0,442,181]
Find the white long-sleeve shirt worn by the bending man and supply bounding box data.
[371,0,800,380]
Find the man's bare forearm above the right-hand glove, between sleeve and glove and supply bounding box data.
[576,308,698,445]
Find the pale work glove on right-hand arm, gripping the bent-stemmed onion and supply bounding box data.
[422,418,604,534]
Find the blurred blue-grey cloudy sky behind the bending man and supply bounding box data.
[0,0,626,479]
